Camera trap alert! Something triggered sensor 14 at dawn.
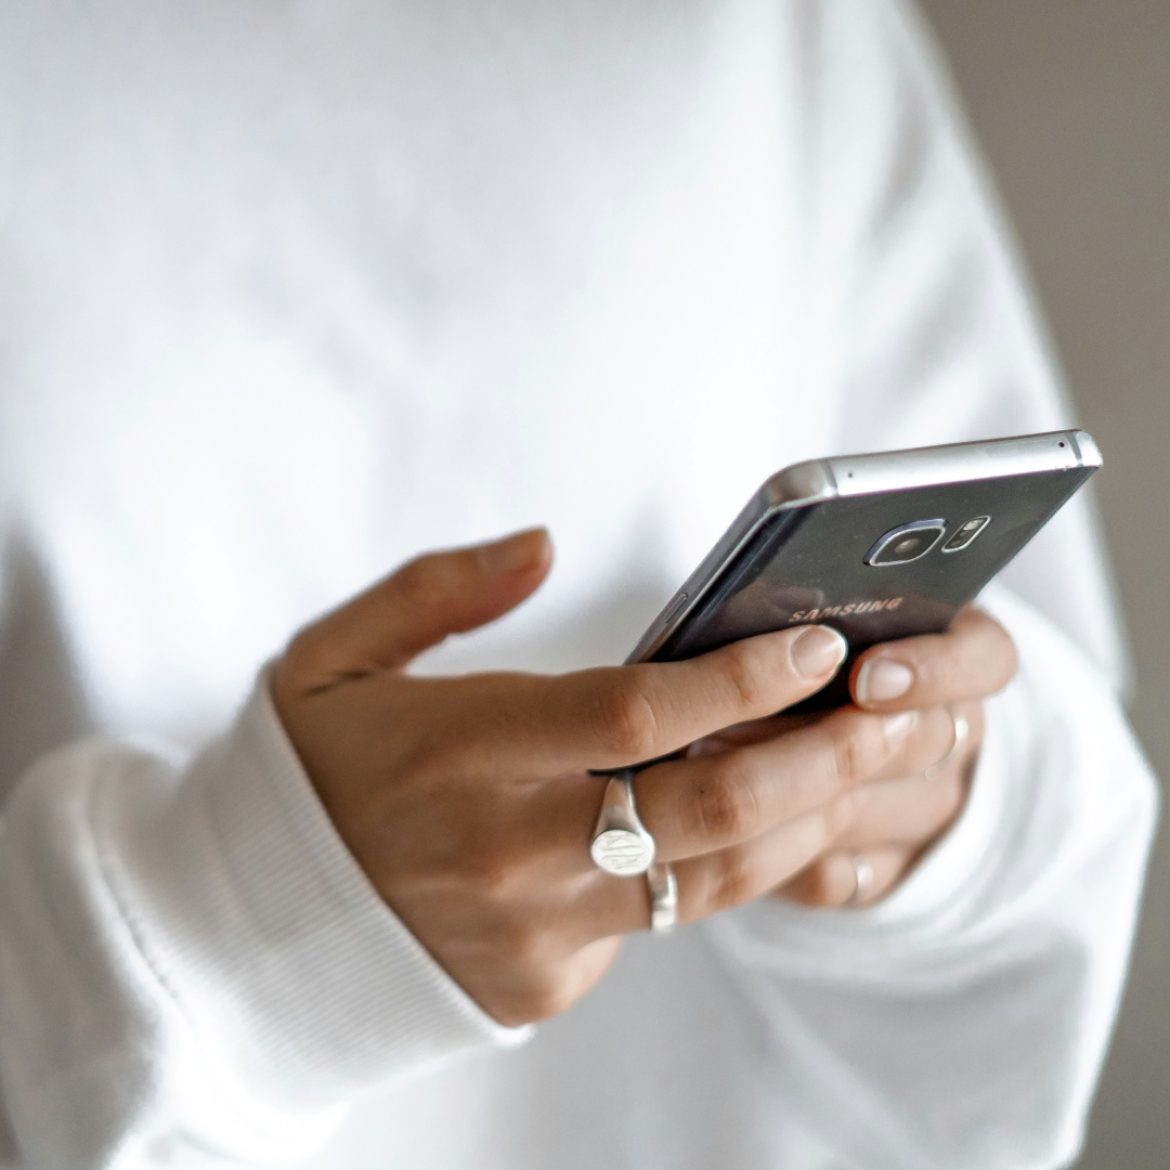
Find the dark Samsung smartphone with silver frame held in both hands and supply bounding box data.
[627,431,1101,708]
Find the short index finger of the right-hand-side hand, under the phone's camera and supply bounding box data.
[849,606,1017,711]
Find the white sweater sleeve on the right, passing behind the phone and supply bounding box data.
[692,0,1156,1170]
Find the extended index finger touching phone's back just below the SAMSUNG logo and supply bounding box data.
[451,626,847,775]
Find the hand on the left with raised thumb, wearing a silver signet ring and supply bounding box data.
[270,529,951,1025]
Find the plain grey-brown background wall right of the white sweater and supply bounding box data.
[922,0,1170,1170]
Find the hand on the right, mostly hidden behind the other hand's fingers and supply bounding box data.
[691,607,1016,907]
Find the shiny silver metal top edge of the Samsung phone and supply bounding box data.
[823,431,1101,496]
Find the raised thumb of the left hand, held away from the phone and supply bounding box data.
[281,528,552,694]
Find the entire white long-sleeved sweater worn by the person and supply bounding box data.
[0,0,1154,1170]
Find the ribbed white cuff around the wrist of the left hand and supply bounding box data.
[96,677,528,1103]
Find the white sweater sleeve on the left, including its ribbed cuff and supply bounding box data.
[0,680,524,1170]
